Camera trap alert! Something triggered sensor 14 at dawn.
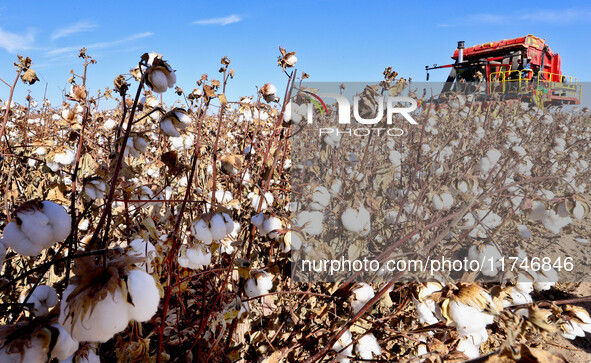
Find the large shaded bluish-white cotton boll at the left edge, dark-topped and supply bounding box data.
[4,200,71,256]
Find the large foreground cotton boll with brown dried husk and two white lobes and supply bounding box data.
[59,255,160,343]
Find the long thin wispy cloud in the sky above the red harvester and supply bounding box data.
[438,9,591,28]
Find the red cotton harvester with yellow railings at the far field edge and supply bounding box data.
[425,35,581,108]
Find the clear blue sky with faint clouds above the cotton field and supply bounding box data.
[0,0,591,105]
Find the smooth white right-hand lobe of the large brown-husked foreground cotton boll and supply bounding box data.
[127,269,160,322]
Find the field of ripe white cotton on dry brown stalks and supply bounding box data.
[0,47,591,363]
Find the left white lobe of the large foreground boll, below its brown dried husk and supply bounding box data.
[59,285,129,343]
